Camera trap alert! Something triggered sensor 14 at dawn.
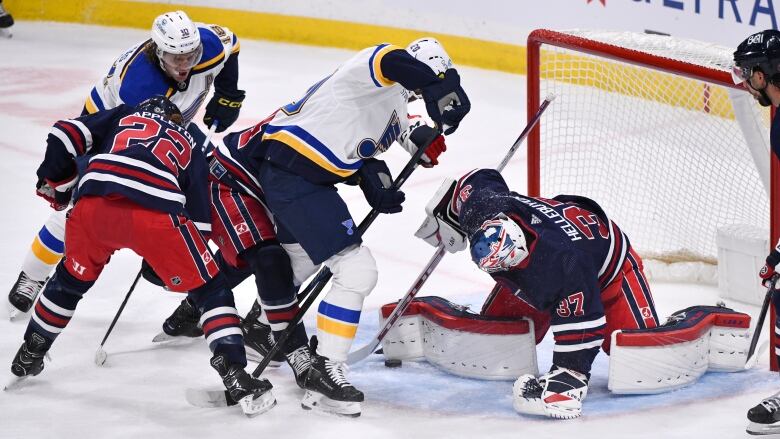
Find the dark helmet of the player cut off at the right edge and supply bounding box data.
[732,29,780,84]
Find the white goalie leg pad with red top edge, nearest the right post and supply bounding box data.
[608,306,750,394]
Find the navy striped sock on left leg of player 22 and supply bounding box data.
[24,263,95,349]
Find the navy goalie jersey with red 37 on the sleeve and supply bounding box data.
[455,170,630,373]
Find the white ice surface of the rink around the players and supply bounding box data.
[0,22,780,439]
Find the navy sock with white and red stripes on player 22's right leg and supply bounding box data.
[189,274,247,366]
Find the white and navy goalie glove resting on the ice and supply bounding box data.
[512,366,588,419]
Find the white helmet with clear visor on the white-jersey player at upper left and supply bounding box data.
[152,11,203,82]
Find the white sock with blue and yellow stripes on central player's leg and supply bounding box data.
[317,245,378,362]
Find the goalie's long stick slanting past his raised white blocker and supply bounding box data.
[347,94,555,364]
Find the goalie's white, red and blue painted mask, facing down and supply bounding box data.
[469,214,528,273]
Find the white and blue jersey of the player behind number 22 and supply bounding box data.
[84,23,240,123]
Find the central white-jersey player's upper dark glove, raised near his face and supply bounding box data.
[421,69,471,134]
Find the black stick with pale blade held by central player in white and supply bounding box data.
[186,125,441,407]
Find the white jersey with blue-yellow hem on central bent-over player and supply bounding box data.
[263,44,416,183]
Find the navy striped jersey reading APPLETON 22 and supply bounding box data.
[37,105,210,230]
